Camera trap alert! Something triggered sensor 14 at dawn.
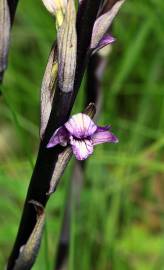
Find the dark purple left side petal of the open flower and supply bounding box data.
[47,127,68,148]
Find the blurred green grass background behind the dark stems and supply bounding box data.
[0,0,164,270]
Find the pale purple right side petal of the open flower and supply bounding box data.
[91,127,118,145]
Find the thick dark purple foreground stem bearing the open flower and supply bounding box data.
[7,0,101,270]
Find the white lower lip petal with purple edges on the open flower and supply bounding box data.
[70,136,93,160]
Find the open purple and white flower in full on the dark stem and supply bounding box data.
[47,113,118,160]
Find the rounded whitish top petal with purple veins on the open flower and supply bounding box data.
[65,113,97,139]
